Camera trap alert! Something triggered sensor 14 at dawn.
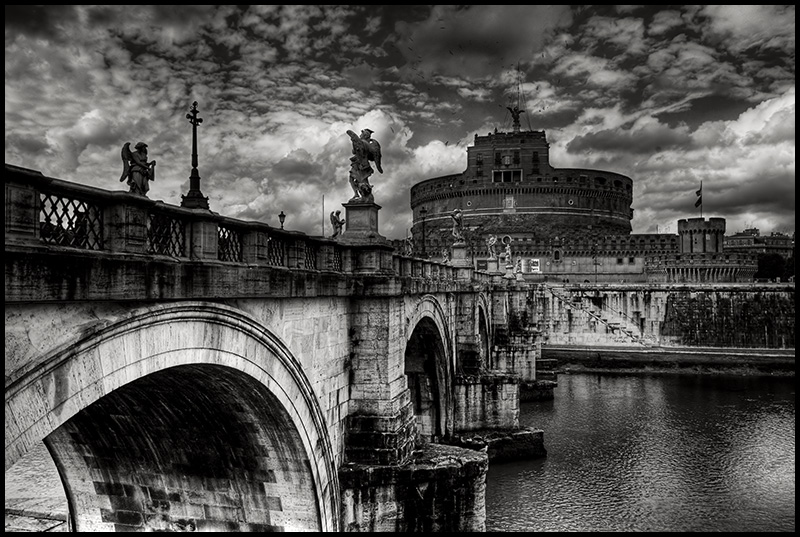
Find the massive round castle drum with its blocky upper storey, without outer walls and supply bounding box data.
[411,127,633,258]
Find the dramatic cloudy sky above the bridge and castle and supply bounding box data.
[5,6,795,238]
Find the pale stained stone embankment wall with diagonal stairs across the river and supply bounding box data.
[529,283,795,349]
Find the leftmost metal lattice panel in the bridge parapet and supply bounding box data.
[39,193,103,250]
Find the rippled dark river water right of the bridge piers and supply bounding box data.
[486,373,795,531]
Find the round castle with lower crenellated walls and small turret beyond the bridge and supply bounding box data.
[411,118,757,283]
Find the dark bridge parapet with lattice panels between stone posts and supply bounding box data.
[5,164,489,299]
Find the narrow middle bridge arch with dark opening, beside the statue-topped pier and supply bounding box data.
[403,295,455,441]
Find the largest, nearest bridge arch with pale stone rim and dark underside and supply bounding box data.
[5,302,340,530]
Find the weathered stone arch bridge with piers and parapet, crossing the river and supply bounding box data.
[5,164,541,531]
